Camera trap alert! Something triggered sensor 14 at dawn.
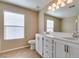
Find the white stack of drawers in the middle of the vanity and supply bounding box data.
[43,37,54,58]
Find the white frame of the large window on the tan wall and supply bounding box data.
[3,11,25,40]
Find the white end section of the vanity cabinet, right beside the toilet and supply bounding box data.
[36,34,44,56]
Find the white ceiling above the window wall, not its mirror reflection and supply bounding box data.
[0,0,52,11]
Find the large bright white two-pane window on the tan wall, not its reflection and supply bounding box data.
[4,11,24,40]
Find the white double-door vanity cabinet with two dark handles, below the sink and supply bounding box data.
[55,41,79,58]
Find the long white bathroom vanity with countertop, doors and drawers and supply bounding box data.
[36,33,79,58]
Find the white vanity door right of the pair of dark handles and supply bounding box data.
[69,46,79,58]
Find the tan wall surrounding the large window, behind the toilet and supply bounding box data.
[0,2,38,50]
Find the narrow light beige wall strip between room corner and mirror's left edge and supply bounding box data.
[38,5,48,34]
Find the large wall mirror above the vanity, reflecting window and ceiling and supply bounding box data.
[44,0,79,33]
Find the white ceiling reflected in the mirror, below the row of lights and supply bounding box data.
[46,0,79,18]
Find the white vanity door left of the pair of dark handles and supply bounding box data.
[55,41,66,58]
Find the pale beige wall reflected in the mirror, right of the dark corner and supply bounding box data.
[62,17,76,33]
